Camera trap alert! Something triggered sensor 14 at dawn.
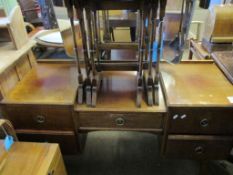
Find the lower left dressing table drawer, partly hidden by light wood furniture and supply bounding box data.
[16,130,78,154]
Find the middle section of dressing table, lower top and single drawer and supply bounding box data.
[74,71,166,134]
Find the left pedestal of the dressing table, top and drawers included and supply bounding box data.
[1,63,77,153]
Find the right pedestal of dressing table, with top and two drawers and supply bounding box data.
[161,62,233,159]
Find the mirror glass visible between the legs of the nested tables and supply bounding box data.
[50,0,186,60]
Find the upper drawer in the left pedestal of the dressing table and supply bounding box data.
[3,105,74,130]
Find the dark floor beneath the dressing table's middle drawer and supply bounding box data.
[64,131,226,175]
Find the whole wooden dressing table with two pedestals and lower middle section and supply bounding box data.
[1,61,233,166]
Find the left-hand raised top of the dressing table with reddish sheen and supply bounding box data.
[2,63,78,105]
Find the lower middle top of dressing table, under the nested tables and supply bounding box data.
[75,71,166,112]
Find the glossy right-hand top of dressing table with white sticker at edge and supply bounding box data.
[161,62,233,107]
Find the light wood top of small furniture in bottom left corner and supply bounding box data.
[0,141,59,175]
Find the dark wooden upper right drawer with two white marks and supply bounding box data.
[168,107,233,135]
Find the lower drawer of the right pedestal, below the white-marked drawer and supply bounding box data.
[165,135,233,159]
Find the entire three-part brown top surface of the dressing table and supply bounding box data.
[2,62,233,108]
